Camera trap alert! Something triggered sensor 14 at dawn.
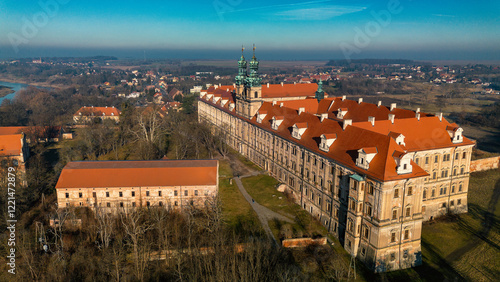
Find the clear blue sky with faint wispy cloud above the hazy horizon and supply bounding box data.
[0,0,500,60]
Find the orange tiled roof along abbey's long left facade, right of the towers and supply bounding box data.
[250,102,428,181]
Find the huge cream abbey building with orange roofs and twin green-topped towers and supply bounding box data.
[198,51,475,272]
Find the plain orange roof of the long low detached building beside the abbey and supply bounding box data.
[56,160,218,189]
